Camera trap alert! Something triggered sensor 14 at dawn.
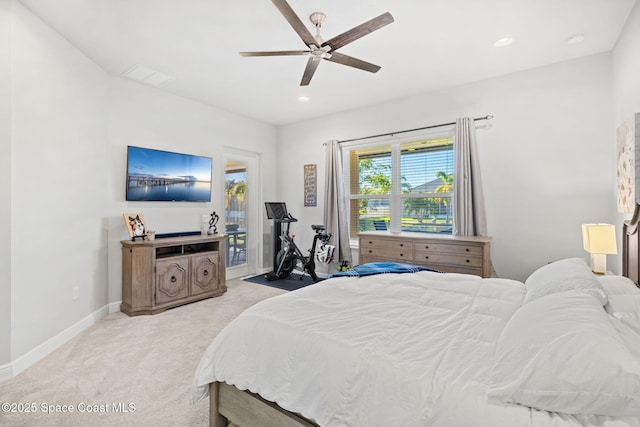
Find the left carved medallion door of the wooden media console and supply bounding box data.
[156,257,189,304]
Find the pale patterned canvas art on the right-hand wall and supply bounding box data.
[616,113,640,213]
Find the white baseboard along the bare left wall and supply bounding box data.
[6,302,112,382]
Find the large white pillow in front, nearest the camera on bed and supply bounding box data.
[488,290,640,416]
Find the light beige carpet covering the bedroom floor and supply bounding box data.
[0,280,286,426]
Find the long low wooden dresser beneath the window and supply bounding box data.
[358,231,491,277]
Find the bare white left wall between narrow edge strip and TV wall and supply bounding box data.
[10,2,108,359]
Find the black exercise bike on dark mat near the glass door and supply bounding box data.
[265,214,331,282]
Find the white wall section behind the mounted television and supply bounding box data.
[105,77,276,302]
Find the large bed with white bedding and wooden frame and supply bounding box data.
[192,210,640,427]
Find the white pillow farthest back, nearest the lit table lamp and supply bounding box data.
[524,258,607,306]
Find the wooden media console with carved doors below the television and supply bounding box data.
[120,234,227,316]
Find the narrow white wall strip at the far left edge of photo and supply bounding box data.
[0,0,12,370]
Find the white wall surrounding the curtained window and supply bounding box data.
[278,54,615,279]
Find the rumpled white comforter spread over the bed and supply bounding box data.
[192,272,640,427]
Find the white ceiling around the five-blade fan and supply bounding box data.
[20,0,635,125]
